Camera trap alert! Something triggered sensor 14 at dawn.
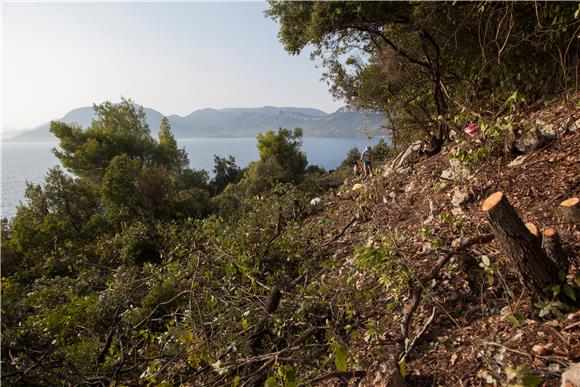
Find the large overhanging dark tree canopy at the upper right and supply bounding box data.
[267,1,580,153]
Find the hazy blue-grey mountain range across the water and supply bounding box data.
[5,106,385,142]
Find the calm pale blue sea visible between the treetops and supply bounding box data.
[1,138,386,218]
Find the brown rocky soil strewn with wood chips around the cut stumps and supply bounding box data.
[309,98,580,386]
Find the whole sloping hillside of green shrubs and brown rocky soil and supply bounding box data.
[2,95,580,387]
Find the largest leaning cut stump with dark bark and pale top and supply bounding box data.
[482,192,559,296]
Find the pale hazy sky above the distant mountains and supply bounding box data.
[2,2,343,129]
